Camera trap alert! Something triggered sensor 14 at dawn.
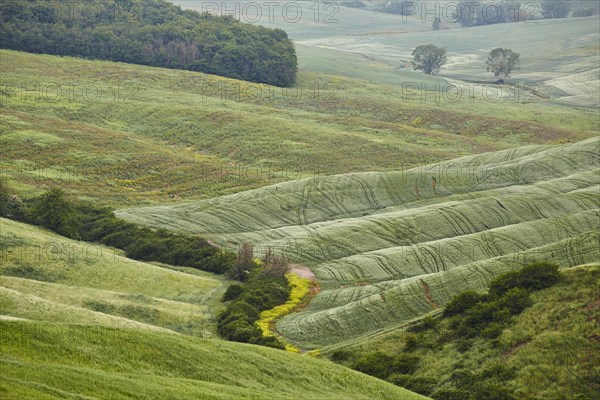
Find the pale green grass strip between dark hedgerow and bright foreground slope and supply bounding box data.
[0,219,227,335]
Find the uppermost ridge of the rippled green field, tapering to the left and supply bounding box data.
[119,139,600,234]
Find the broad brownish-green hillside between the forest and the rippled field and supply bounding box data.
[0,51,599,205]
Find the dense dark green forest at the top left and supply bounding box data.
[0,0,297,87]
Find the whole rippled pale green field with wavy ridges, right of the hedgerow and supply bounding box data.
[119,139,600,348]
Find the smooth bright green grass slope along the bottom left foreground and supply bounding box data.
[0,321,432,400]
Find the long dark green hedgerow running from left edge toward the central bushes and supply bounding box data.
[0,186,235,274]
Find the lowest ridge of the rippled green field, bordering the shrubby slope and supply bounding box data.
[277,231,600,348]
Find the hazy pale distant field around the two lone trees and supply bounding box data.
[174,0,600,108]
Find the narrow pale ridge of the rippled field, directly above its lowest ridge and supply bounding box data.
[313,210,600,288]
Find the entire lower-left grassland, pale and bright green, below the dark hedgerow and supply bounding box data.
[0,219,432,400]
